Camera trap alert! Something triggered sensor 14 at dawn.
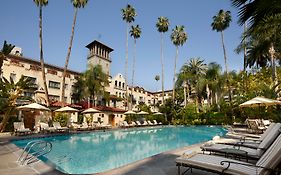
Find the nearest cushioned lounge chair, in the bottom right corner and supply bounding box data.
[176,135,281,175]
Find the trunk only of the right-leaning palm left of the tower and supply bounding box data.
[60,8,78,107]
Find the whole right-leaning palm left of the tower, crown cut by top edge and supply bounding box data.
[60,0,88,107]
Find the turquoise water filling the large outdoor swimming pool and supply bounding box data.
[13,126,227,174]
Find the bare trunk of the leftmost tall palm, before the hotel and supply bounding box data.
[39,5,50,106]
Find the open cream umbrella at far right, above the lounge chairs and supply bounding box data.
[239,97,281,107]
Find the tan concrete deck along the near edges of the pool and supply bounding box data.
[0,127,241,175]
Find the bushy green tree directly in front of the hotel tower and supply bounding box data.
[82,65,109,106]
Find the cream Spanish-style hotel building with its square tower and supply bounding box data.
[2,40,171,125]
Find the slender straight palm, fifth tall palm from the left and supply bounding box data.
[156,16,170,104]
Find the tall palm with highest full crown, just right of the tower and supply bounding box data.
[121,4,137,108]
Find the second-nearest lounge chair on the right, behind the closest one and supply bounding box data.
[201,123,281,159]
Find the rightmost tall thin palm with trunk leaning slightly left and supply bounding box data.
[211,9,231,104]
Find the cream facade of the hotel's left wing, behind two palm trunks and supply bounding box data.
[3,55,80,104]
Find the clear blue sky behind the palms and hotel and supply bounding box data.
[0,0,243,91]
